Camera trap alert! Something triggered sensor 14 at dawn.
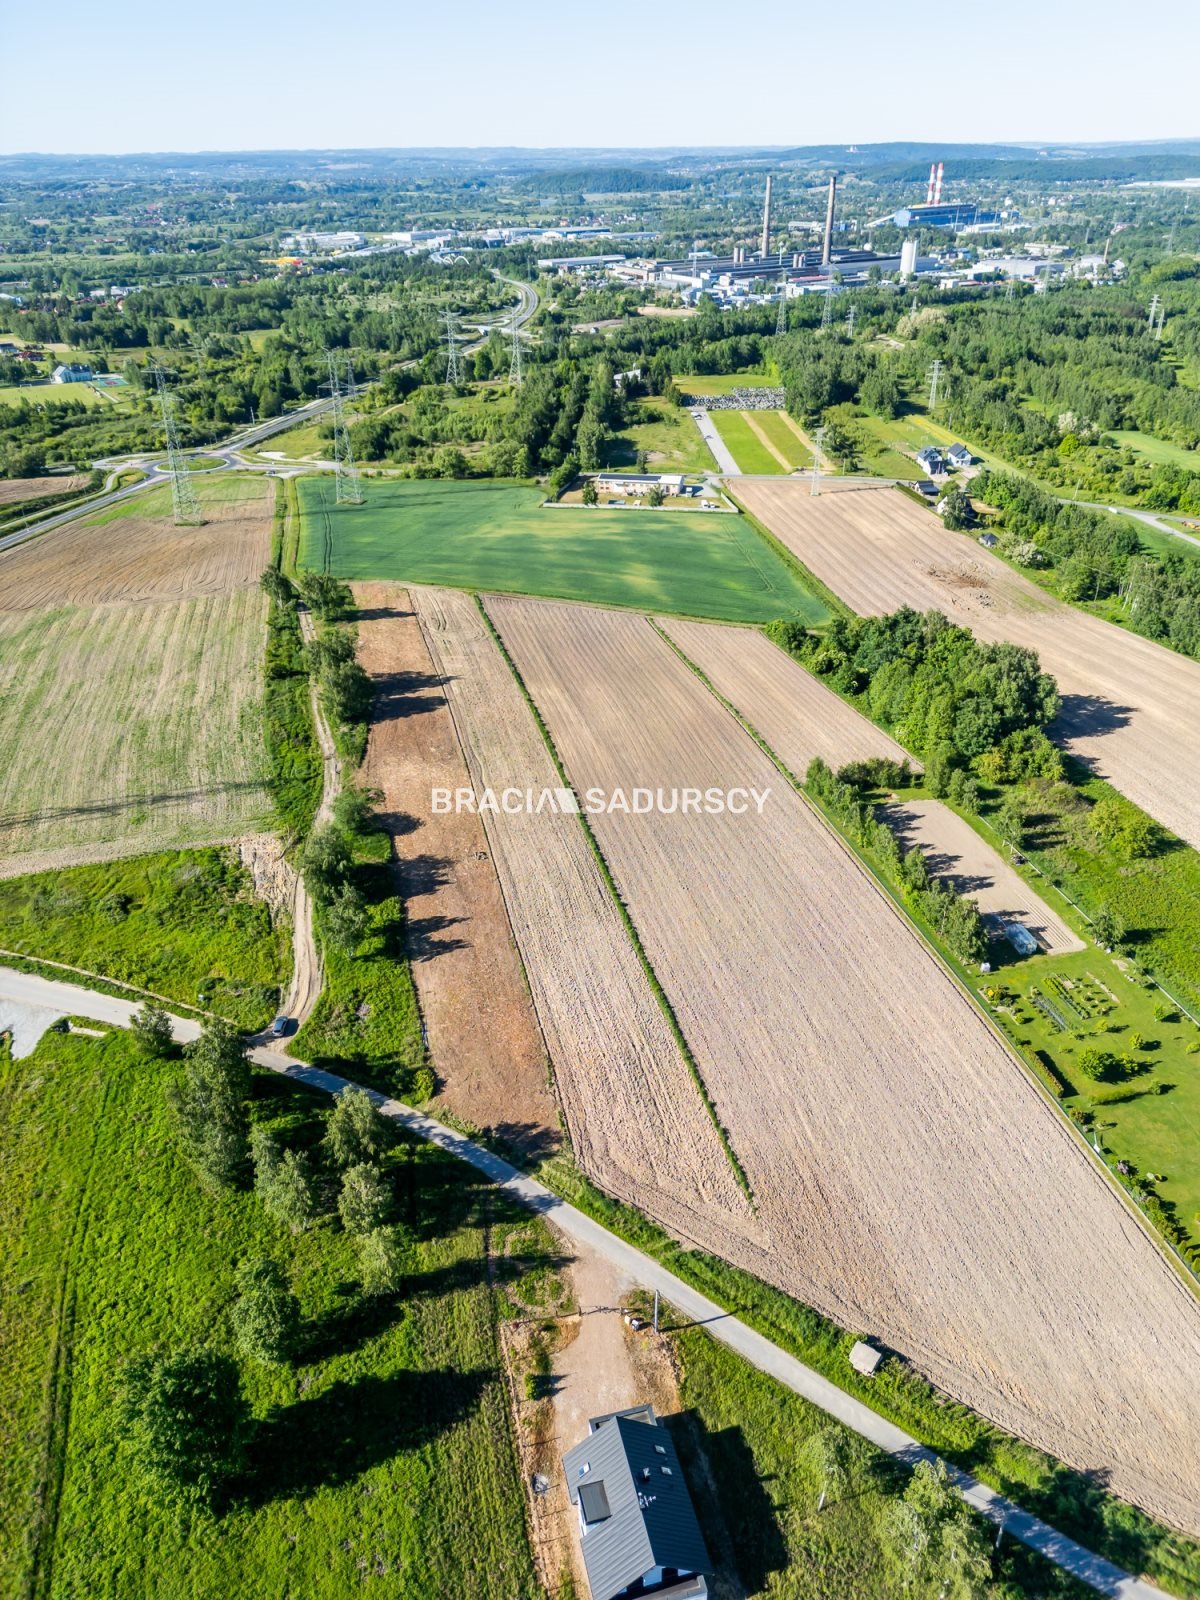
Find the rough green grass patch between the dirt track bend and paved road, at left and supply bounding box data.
[0,850,291,1027]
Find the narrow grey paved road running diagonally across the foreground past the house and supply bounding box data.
[0,966,1171,1600]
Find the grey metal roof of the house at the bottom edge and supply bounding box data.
[563,1416,712,1600]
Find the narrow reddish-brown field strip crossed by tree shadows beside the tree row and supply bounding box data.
[355,584,558,1149]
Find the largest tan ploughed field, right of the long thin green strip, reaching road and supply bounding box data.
[488,598,1200,1531]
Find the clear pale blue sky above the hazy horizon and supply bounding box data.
[0,0,1200,152]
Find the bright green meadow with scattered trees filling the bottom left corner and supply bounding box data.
[0,1034,550,1600]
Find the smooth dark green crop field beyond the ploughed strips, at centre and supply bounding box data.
[298,477,827,624]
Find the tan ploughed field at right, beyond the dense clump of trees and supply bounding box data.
[739,483,1200,846]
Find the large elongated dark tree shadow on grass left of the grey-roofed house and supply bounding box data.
[245,1368,496,1506]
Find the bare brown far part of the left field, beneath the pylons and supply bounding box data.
[0,480,274,611]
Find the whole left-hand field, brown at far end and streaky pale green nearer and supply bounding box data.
[0,480,270,875]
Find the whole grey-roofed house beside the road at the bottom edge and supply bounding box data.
[563,1405,712,1600]
